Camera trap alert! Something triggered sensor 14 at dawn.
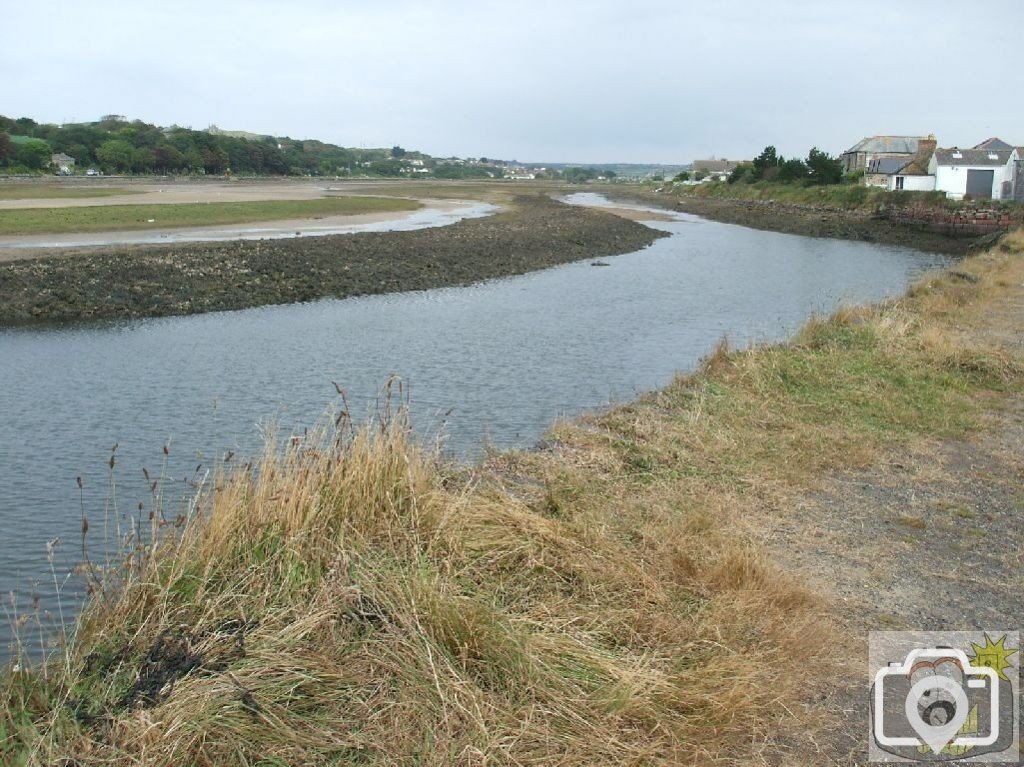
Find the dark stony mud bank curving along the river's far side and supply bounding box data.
[0,196,666,326]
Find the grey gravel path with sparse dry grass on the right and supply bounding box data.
[763,249,1024,765]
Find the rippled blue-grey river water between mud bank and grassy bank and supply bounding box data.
[0,195,948,661]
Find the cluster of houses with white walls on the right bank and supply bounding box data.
[842,135,1024,202]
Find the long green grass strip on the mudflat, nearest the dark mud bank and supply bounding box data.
[0,197,421,235]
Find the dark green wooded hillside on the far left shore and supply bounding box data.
[0,115,415,175]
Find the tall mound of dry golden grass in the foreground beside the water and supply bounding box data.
[4,418,822,765]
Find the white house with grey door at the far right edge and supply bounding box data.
[928,148,1017,200]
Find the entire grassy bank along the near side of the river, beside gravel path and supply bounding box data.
[0,226,1024,766]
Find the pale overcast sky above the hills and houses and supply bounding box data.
[0,0,1024,164]
